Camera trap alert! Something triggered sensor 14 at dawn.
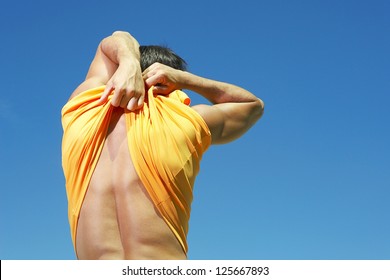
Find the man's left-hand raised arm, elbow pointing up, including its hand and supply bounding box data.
[72,31,145,110]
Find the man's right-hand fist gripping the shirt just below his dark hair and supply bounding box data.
[142,62,183,94]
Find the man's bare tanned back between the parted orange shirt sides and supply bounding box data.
[76,108,186,259]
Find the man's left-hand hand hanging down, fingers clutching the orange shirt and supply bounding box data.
[100,61,145,111]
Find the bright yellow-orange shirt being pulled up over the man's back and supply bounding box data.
[62,86,211,253]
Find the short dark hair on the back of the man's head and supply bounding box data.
[139,46,187,71]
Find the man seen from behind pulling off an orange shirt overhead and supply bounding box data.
[62,32,264,259]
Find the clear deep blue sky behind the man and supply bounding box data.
[0,0,390,260]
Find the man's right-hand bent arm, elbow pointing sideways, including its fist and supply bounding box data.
[143,63,264,144]
